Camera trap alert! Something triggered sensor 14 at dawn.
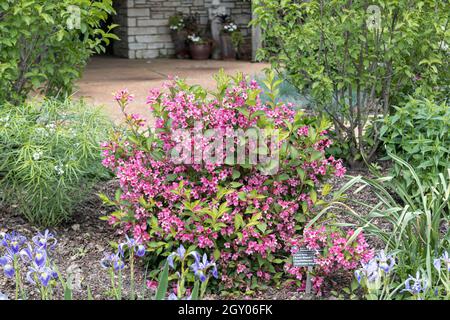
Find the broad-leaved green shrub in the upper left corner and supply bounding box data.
[0,0,117,103]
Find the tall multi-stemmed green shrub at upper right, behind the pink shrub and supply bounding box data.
[252,0,450,166]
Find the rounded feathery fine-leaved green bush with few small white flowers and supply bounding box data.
[0,100,109,226]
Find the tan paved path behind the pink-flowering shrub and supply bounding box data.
[75,57,268,121]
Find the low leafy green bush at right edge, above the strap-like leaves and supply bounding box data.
[380,98,450,202]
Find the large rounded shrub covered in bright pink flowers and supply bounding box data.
[103,73,345,290]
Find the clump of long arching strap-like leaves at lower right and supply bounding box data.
[317,154,450,299]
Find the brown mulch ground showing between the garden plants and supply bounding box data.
[0,171,386,300]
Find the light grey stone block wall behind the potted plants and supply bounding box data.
[113,0,251,59]
